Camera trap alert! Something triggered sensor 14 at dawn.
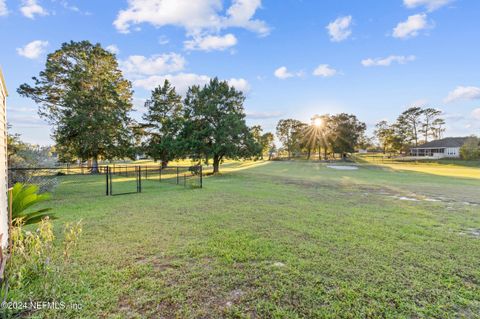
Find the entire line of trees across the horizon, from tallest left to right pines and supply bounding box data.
[18,41,445,169]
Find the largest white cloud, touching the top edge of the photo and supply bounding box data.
[113,0,270,35]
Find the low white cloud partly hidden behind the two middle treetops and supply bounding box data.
[133,73,250,94]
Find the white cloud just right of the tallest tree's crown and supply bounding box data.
[120,53,186,77]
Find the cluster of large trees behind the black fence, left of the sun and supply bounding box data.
[17,41,262,173]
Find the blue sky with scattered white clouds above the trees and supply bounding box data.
[0,0,480,145]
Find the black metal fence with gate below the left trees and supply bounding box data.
[8,164,203,195]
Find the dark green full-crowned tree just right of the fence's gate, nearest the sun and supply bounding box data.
[183,78,261,173]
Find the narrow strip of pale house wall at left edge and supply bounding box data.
[0,68,8,247]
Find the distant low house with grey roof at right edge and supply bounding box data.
[410,137,467,158]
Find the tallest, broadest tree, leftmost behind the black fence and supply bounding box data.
[18,41,132,172]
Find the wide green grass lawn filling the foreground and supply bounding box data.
[13,162,480,318]
